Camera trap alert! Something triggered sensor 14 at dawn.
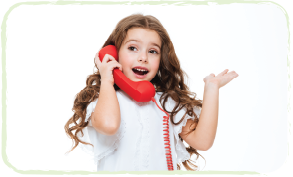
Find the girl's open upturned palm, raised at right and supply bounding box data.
[203,69,238,88]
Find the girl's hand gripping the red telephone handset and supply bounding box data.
[95,52,122,85]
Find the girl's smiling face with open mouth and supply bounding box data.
[119,28,162,81]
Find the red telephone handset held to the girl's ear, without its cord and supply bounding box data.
[99,45,156,102]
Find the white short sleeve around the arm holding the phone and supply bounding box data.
[78,99,125,165]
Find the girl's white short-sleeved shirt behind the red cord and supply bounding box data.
[78,90,201,171]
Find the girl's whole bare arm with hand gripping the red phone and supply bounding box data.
[91,52,122,135]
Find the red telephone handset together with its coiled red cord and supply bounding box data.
[99,45,173,170]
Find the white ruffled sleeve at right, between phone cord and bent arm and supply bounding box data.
[168,99,201,162]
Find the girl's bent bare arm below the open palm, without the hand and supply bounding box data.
[179,83,219,151]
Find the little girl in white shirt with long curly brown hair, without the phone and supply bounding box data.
[65,14,238,171]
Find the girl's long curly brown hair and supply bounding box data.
[64,14,202,171]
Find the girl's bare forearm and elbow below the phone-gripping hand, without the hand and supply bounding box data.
[91,81,121,135]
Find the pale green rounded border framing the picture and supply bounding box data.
[0,0,292,176]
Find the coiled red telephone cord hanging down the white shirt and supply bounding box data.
[152,98,174,171]
